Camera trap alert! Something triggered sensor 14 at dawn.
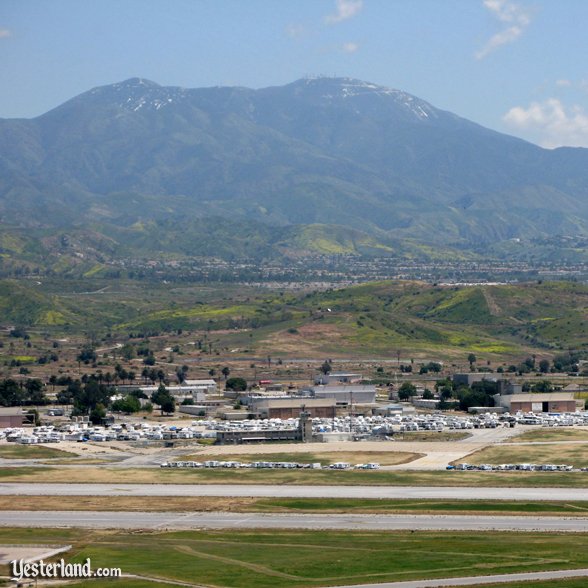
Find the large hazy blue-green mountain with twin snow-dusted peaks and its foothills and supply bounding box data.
[0,78,588,256]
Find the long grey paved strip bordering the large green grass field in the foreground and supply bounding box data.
[0,511,588,533]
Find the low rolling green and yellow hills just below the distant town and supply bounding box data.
[0,280,588,358]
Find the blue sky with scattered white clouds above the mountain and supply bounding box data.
[0,0,588,147]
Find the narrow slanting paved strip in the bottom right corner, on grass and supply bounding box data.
[330,568,588,588]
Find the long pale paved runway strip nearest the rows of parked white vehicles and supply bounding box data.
[0,482,588,501]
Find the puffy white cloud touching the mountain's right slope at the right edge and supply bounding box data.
[503,98,588,148]
